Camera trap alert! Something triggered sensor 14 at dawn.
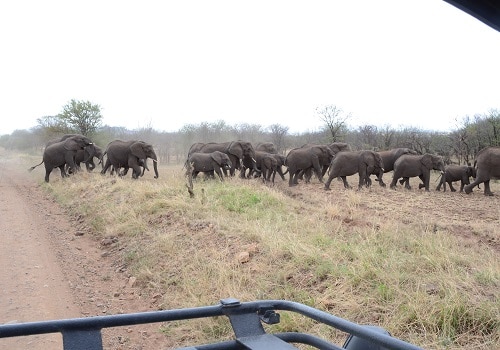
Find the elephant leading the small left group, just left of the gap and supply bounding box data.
[101,140,158,179]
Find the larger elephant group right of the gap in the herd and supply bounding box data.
[186,141,500,195]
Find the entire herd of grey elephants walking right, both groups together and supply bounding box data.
[29,134,500,196]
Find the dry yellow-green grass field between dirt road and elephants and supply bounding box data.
[28,161,500,349]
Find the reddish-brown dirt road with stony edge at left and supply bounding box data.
[0,157,165,350]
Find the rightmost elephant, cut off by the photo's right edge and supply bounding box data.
[464,146,500,196]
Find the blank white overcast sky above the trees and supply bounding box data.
[0,0,500,135]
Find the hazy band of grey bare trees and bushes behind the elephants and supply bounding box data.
[0,110,500,164]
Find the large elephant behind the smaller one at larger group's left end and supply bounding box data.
[188,140,255,176]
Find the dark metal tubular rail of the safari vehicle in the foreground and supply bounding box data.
[0,298,420,350]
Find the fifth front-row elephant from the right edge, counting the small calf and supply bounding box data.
[285,145,335,187]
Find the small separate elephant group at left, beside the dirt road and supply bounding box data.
[28,134,158,182]
